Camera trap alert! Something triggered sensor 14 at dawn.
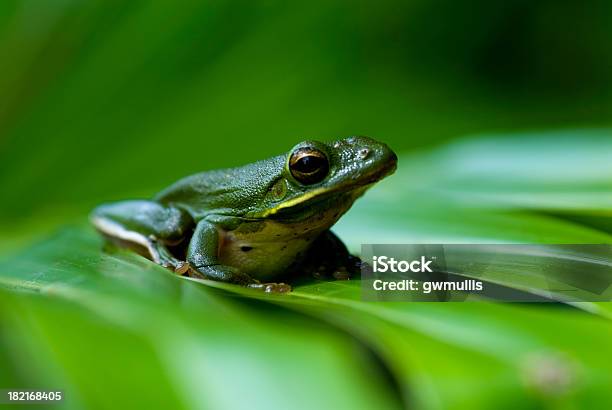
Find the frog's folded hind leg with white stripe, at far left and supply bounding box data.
[91,201,193,274]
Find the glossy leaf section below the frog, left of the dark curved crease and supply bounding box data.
[0,230,398,409]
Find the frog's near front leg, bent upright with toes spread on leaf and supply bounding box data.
[187,220,291,293]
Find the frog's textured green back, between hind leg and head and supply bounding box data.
[154,155,285,221]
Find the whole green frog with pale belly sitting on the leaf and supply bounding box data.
[90,136,397,293]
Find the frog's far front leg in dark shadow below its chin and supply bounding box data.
[302,230,362,279]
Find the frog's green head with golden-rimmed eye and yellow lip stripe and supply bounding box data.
[250,137,397,226]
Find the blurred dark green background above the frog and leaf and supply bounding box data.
[0,0,612,224]
